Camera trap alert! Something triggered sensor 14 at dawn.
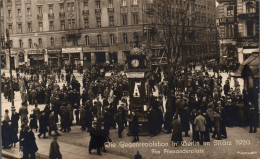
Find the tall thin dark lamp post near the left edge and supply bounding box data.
[6,29,15,110]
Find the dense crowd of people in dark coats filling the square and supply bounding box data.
[2,62,257,158]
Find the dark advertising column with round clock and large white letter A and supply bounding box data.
[126,47,150,135]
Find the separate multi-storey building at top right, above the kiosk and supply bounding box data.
[218,0,259,64]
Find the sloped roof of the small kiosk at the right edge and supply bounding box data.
[233,53,259,77]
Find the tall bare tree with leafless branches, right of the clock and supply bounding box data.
[145,0,196,111]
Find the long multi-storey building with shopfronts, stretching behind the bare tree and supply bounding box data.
[1,0,216,68]
